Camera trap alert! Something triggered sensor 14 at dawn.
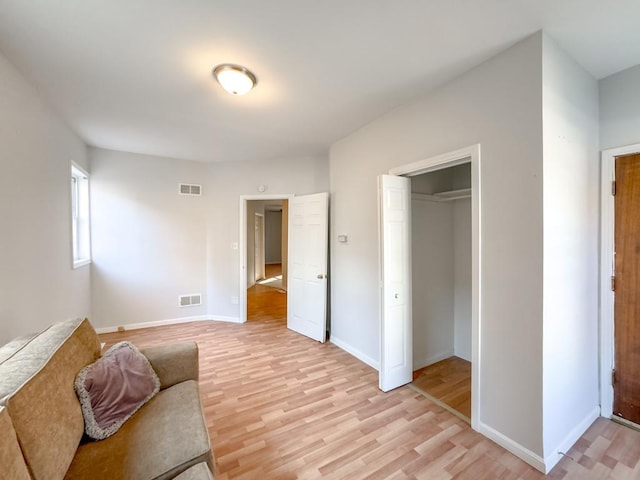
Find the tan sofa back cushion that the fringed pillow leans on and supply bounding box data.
[0,319,100,480]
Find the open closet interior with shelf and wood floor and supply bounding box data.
[410,161,472,423]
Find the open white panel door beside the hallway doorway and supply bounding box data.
[287,193,329,343]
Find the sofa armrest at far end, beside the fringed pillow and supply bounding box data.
[140,342,199,389]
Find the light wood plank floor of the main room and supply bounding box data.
[101,318,640,480]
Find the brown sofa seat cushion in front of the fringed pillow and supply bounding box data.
[65,380,213,480]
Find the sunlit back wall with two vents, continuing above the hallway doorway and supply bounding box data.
[91,149,328,328]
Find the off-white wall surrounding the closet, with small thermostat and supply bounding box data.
[330,34,542,458]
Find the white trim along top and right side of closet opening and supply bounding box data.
[389,143,482,431]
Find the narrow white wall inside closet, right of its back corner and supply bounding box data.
[451,198,471,362]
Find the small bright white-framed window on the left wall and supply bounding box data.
[71,165,91,268]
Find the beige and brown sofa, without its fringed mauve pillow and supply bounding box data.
[0,319,213,480]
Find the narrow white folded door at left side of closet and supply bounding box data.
[378,175,413,392]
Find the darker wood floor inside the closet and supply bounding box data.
[413,357,471,419]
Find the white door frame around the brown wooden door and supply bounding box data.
[600,144,640,418]
